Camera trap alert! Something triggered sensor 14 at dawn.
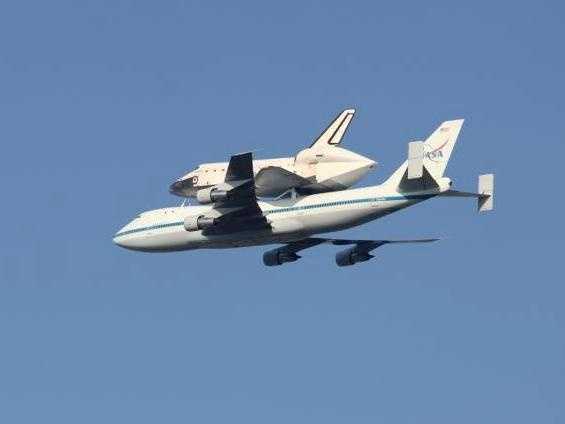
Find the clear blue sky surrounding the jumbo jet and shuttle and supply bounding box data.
[0,1,565,424]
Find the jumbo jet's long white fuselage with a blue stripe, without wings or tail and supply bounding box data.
[114,181,447,252]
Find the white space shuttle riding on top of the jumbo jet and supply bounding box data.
[169,109,376,203]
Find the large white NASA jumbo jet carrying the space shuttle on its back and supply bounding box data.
[113,119,494,266]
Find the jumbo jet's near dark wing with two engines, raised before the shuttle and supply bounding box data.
[207,153,269,234]
